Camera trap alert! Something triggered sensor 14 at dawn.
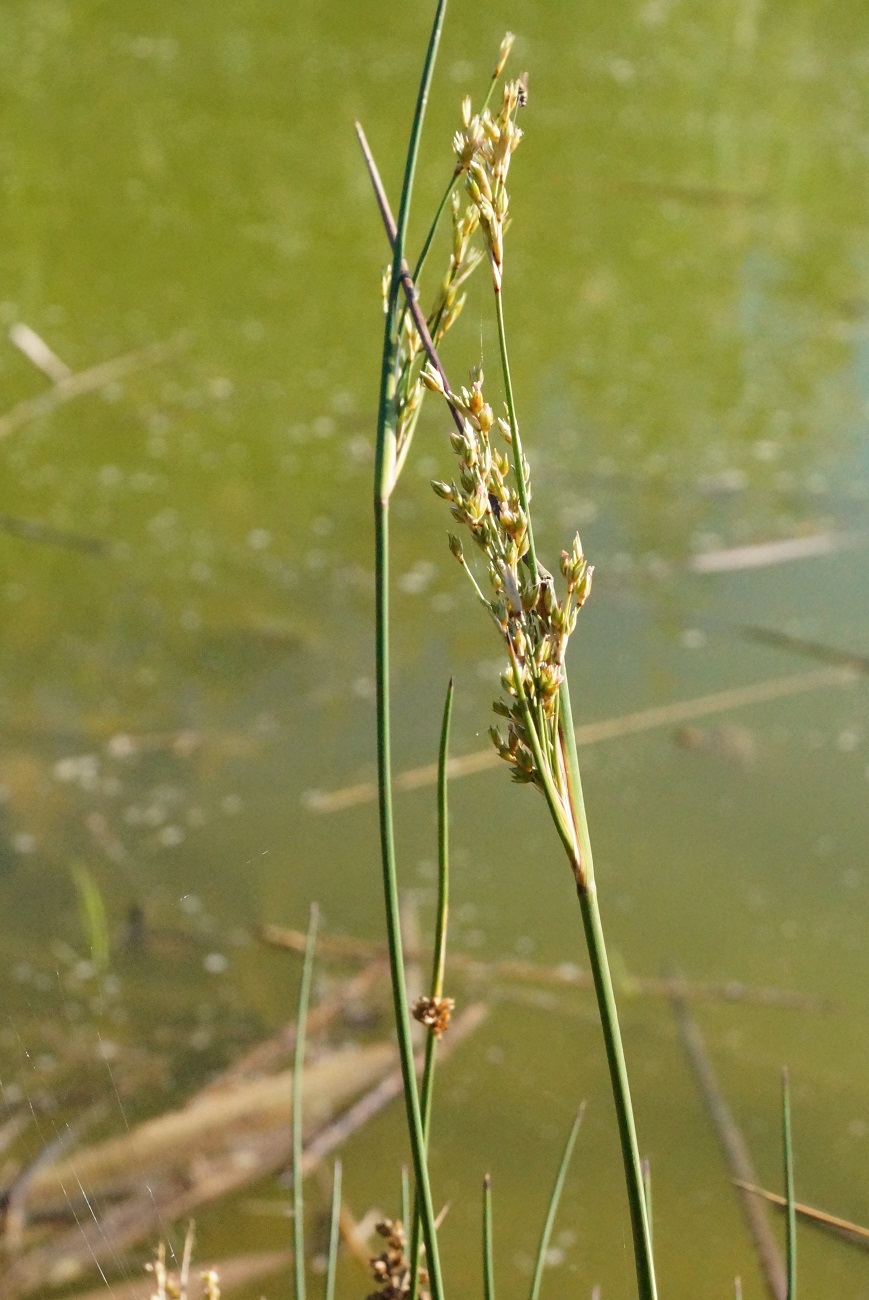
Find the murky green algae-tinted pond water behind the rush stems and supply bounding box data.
[0,0,869,1300]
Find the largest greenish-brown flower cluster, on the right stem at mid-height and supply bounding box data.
[423,367,593,788]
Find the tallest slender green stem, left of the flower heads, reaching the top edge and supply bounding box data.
[375,0,446,1300]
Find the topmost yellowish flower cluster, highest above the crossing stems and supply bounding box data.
[453,79,527,291]
